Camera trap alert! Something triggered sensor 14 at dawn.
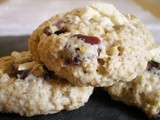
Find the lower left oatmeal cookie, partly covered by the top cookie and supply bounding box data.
[0,52,93,116]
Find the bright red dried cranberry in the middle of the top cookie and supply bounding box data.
[74,34,101,45]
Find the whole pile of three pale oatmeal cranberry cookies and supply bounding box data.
[0,3,160,116]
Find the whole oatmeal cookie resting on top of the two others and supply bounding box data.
[29,3,153,86]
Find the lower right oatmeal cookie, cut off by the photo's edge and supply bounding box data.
[106,47,160,117]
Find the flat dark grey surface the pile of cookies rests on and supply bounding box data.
[0,36,156,120]
